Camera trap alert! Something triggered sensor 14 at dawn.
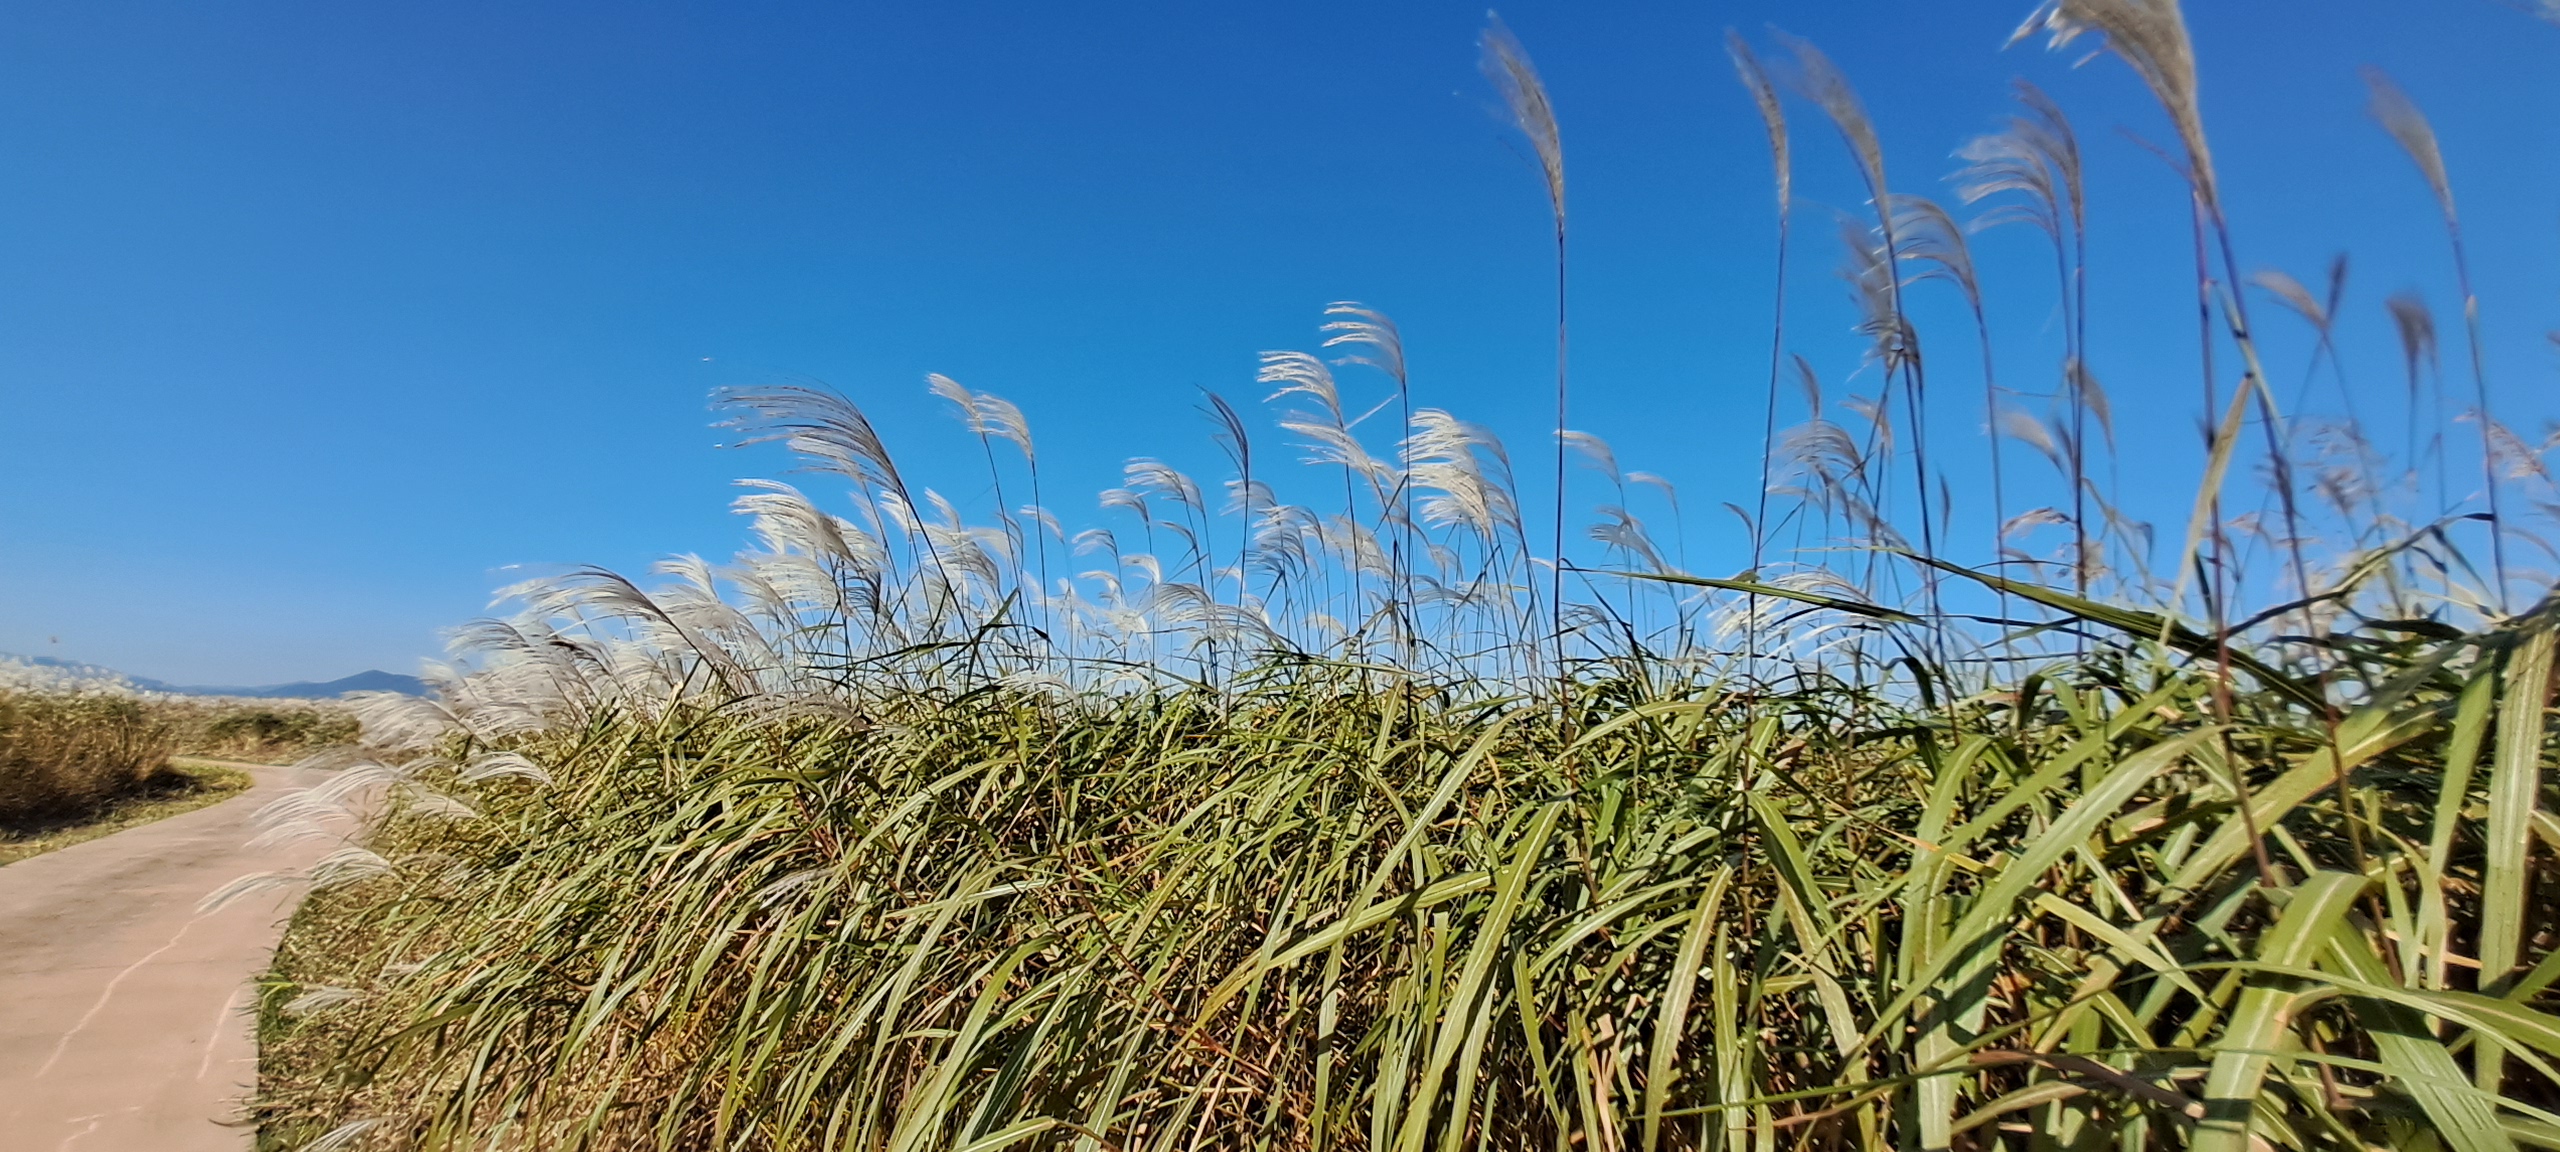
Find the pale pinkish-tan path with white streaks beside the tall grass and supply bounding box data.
[0,768,330,1152]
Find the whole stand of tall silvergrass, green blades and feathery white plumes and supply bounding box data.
[244,0,2560,1152]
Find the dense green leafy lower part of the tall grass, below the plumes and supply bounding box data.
[264,614,2560,1149]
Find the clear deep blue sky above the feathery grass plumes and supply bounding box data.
[0,0,2560,684]
